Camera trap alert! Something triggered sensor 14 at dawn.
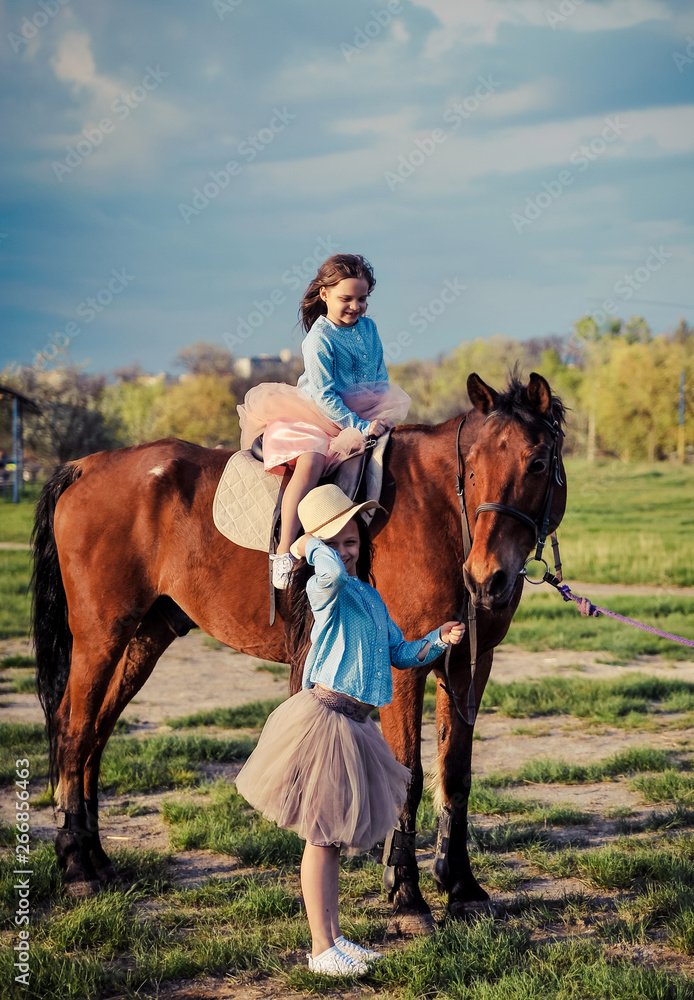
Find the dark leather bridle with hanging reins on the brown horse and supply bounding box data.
[442,410,564,726]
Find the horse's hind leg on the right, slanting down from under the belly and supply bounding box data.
[84,599,185,883]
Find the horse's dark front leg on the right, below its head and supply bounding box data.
[434,650,493,919]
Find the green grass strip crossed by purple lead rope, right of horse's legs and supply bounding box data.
[504,586,694,662]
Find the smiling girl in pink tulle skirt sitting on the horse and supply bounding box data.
[238,254,410,590]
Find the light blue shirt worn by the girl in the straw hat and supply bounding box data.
[302,538,446,706]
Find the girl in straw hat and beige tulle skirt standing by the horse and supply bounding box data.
[236,484,464,975]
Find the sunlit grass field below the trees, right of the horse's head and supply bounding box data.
[559,460,694,588]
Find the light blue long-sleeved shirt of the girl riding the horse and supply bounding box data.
[297,316,388,436]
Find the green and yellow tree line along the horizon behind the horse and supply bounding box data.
[0,316,694,470]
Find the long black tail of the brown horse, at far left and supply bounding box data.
[31,462,82,788]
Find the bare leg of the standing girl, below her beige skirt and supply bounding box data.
[301,841,340,958]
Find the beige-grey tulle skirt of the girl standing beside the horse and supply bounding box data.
[236,689,410,855]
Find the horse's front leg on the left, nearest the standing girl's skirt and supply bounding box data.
[381,669,434,935]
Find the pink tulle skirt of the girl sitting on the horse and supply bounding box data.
[238,382,410,473]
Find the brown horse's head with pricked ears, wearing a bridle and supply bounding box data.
[464,372,566,610]
